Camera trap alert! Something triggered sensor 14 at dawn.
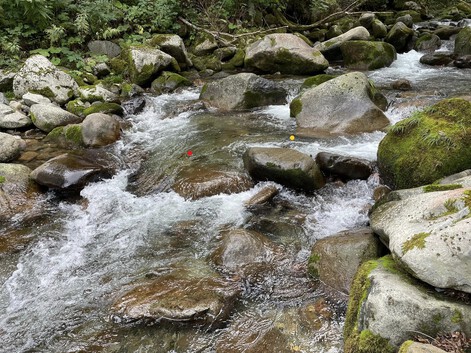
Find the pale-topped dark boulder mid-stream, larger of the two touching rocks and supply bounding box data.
[243,147,325,192]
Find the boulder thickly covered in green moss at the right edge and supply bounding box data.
[378,98,471,189]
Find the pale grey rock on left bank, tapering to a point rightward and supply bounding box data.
[30,104,82,132]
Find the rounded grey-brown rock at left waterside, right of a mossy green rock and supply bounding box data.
[81,113,120,147]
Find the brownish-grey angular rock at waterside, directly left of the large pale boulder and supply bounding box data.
[308,228,383,294]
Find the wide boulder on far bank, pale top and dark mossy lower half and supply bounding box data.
[245,33,329,75]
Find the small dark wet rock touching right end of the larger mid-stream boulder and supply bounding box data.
[316,152,373,180]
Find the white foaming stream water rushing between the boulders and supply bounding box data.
[0,52,471,353]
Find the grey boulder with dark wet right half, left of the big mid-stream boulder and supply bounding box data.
[200,73,287,110]
